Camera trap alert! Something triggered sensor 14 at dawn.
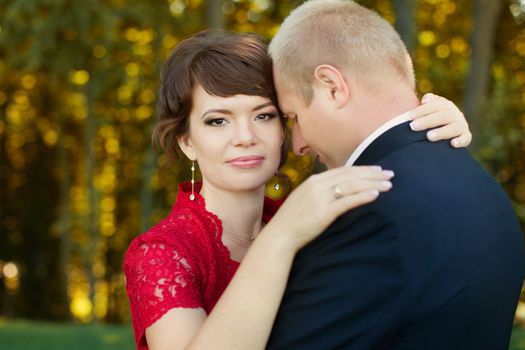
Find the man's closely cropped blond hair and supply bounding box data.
[269,0,415,103]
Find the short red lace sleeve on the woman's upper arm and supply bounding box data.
[124,238,202,348]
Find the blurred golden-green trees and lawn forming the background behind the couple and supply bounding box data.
[0,0,525,349]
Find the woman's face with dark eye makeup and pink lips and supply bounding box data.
[179,86,284,191]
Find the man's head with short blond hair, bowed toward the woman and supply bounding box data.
[269,0,414,166]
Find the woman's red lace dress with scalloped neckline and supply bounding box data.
[124,183,280,350]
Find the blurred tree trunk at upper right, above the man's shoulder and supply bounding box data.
[463,0,502,151]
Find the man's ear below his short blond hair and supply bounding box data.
[314,64,350,108]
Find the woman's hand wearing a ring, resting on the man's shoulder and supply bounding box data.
[266,166,394,251]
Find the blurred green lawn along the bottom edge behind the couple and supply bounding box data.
[0,319,525,350]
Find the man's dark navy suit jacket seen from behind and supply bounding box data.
[267,123,525,350]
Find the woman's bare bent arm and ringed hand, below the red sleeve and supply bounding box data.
[146,167,393,350]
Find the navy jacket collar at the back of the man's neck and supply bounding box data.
[354,122,427,165]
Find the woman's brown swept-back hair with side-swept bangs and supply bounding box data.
[152,30,287,166]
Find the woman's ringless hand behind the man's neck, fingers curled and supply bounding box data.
[410,94,472,148]
